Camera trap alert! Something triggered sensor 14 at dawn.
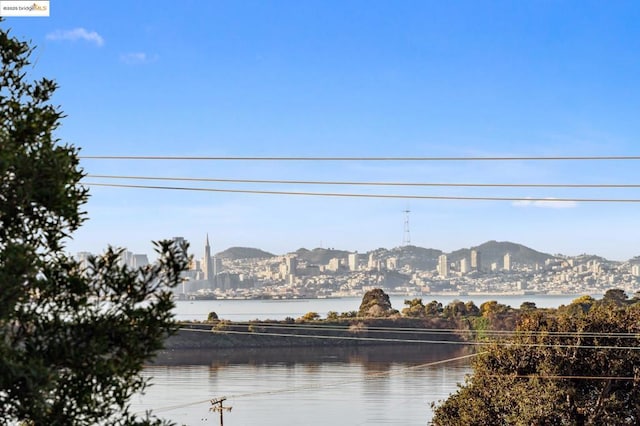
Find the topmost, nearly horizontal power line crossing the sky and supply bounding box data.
[78,155,640,161]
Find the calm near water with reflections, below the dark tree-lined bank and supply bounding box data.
[133,345,469,426]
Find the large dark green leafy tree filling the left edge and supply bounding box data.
[0,25,188,425]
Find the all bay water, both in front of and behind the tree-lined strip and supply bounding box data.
[132,295,577,426]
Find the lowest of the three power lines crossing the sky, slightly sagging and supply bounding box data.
[84,182,640,203]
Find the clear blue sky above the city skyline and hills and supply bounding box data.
[7,0,640,260]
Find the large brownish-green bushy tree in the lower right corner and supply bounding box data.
[433,304,640,426]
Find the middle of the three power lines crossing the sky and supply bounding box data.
[86,174,640,188]
